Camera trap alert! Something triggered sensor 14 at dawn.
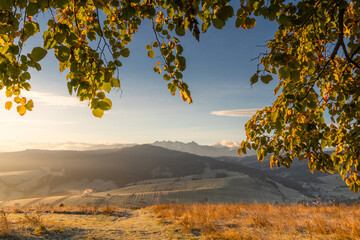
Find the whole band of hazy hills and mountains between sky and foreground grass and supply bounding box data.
[0,142,358,207]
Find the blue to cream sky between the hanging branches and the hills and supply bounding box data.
[0,10,277,151]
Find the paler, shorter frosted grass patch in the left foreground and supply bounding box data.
[0,205,191,240]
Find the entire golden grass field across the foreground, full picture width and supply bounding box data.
[0,204,360,240]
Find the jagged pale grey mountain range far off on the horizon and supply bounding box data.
[152,141,256,157]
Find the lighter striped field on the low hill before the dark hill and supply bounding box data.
[0,173,308,207]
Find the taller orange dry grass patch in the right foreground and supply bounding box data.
[152,204,360,240]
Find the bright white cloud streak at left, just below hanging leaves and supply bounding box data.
[26,91,86,107]
